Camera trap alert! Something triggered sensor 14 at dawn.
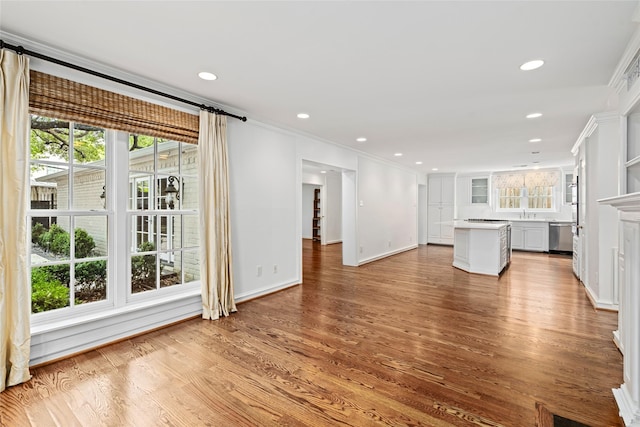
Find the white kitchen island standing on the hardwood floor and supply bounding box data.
[453,221,511,276]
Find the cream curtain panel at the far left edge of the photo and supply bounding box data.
[0,49,31,391]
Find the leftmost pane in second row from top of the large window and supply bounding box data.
[30,163,69,209]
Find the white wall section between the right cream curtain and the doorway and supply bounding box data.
[228,120,302,301]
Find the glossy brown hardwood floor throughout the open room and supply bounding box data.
[0,244,622,427]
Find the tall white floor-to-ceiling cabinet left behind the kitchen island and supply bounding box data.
[427,174,455,245]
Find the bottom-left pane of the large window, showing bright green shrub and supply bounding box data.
[31,264,70,313]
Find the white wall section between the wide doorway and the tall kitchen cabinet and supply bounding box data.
[357,157,418,263]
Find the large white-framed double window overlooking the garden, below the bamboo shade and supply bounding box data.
[27,115,199,319]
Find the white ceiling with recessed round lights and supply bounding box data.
[0,0,638,172]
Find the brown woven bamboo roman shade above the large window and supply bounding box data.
[29,70,199,144]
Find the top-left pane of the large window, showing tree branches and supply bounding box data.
[30,115,69,162]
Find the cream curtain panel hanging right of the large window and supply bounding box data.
[198,110,237,320]
